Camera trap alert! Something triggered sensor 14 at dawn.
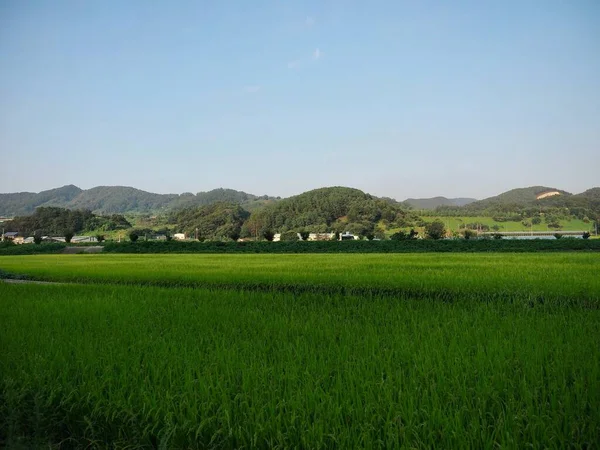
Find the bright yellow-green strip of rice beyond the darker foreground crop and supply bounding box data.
[0,253,600,307]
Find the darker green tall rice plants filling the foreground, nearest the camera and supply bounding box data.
[0,284,600,449]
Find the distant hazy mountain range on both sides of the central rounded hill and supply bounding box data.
[0,185,600,217]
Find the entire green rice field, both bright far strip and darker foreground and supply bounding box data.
[0,252,600,448]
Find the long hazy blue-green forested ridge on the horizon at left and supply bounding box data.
[0,185,274,216]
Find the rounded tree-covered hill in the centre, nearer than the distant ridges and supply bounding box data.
[241,187,410,235]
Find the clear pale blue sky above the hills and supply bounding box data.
[0,0,600,200]
